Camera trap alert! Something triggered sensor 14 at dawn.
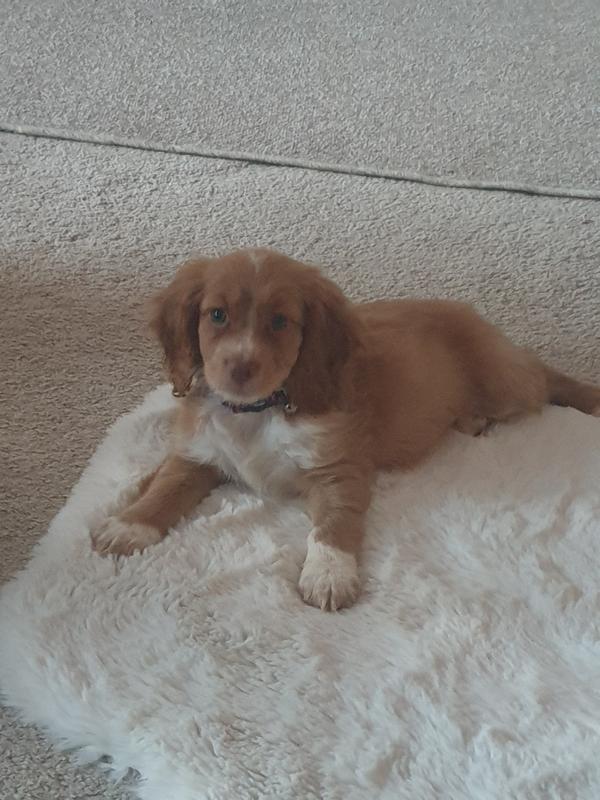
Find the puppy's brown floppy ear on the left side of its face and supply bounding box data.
[150,261,207,397]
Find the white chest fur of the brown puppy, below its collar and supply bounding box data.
[182,398,319,495]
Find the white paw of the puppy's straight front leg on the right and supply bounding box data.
[299,535,360,611]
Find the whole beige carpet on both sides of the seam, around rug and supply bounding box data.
[0,0,600,800]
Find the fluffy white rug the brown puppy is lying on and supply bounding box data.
[0,387,600,800]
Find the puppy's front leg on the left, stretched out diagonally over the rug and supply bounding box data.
[92,456,223,555]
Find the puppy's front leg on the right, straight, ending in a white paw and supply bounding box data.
[300,468,371,611]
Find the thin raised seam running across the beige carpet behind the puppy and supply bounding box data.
[0,122,600,201]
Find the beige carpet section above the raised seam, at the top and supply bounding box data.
[0,0,600,193]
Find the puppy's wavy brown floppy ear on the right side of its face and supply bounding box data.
[286,270,359,414]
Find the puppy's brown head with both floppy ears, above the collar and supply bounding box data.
[152,250,356,413]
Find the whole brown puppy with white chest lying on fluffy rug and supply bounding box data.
[92,250,600,610]
